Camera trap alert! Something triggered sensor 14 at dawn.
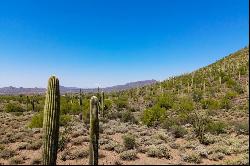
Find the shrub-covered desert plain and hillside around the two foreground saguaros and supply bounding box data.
[0,47,249,165]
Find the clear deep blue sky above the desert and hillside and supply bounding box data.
[0,0,249,88]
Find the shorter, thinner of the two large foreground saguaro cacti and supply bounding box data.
[89,96,99,165]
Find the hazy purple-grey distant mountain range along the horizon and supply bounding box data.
[0,80,157,95]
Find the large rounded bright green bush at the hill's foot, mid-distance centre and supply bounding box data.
[141,105,166,126]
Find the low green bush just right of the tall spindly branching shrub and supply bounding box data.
[207,121,227,134]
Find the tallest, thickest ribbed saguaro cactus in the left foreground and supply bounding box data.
[43,76,60,165]
